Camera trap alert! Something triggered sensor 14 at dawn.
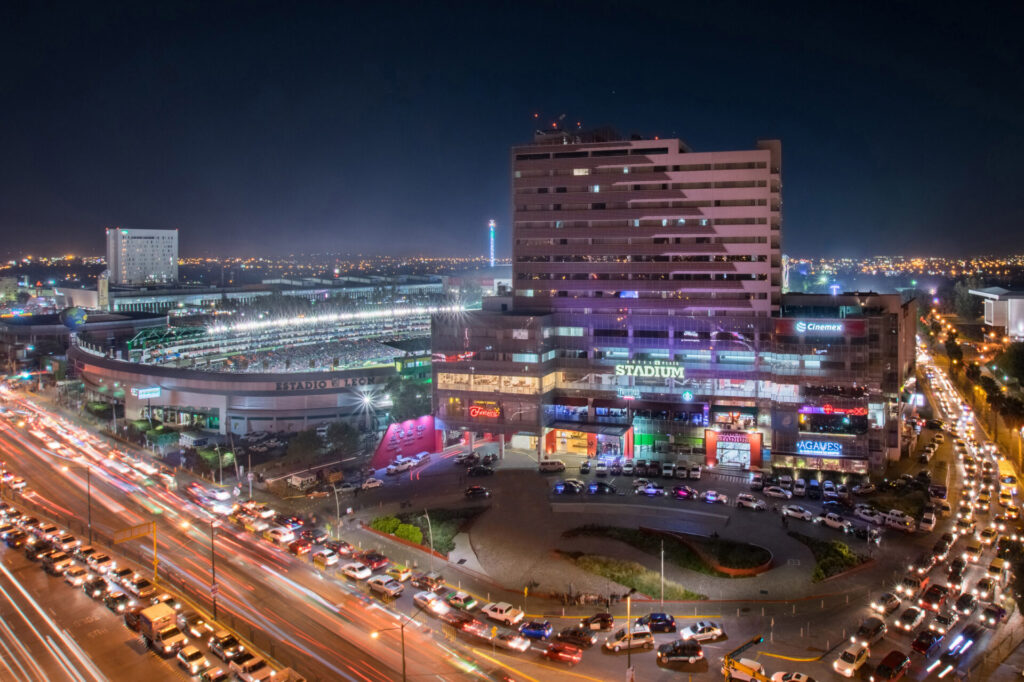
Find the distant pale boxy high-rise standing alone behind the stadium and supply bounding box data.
[106,227,178,286]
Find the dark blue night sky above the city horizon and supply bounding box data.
[0,0,1024,256]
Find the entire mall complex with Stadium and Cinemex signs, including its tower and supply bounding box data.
[431,131,915,473]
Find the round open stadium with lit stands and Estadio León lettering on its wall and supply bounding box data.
[68,305,461,435]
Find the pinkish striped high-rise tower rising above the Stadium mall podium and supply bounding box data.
[512,131,782,316]
